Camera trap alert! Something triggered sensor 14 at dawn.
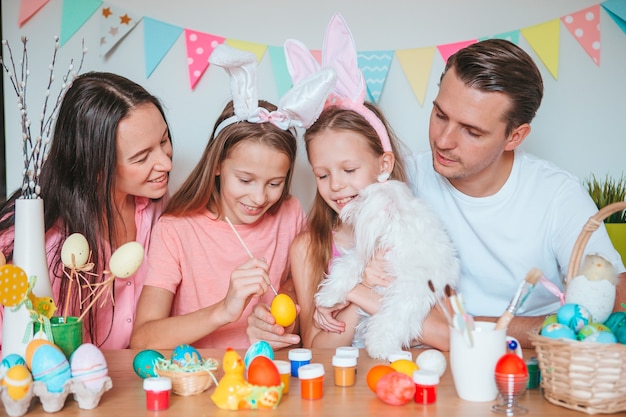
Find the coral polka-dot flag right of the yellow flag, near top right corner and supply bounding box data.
[561,4,600,65]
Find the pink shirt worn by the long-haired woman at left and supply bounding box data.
[0,197,164,349]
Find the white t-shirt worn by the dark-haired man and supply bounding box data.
[407,151,624,316]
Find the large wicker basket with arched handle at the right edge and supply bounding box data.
[530,202,626,414]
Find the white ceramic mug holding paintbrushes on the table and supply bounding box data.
[450,321,522,401]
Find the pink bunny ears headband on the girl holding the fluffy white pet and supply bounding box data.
[285,14,392,152]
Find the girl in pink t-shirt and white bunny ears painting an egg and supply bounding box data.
[131,45,334,348]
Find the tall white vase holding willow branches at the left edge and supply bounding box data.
[2,199,52,357]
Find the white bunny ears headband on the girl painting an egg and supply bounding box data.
[209,44,336,137]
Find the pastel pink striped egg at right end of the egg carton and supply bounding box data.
[70,343,109,392]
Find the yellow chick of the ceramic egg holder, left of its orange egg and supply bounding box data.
[211,348,251,410]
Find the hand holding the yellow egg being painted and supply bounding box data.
[246,303,300,350]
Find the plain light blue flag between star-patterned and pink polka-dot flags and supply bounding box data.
[143,16,183,78]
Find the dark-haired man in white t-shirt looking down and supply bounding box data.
[407,39,626,346]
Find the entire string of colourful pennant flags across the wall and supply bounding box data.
[12,0,626,105]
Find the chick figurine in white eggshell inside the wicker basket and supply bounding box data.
[565,254,618,323]
